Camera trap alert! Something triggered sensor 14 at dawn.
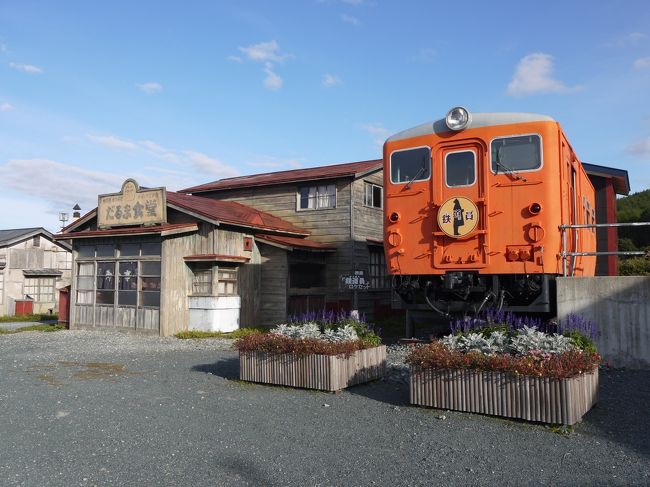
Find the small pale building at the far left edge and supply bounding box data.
[0,227,72,316]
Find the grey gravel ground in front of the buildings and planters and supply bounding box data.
[0,331,650,486]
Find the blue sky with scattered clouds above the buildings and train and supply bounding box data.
[0,0,650,230]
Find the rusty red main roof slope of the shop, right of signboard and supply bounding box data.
[167,191,309,236]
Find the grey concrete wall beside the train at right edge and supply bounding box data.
[557,276,650,369]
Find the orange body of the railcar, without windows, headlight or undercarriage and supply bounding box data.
[384,114,596,282]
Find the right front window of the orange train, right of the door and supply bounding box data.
[491,135,542,173]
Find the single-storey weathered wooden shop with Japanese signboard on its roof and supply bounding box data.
[57,179,342,336]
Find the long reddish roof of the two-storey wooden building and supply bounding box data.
[179,159,382,194]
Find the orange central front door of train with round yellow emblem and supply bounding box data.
[432,142,487,270]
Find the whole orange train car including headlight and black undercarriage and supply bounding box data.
[384,107,596,314]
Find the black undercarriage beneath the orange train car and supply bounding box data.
[393,272,555,316]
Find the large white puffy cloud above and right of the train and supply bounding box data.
[507,52,582,96]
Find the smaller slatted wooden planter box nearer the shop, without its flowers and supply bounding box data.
[239,345,386,391]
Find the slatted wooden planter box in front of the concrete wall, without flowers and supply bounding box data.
[410,366,598,425]
